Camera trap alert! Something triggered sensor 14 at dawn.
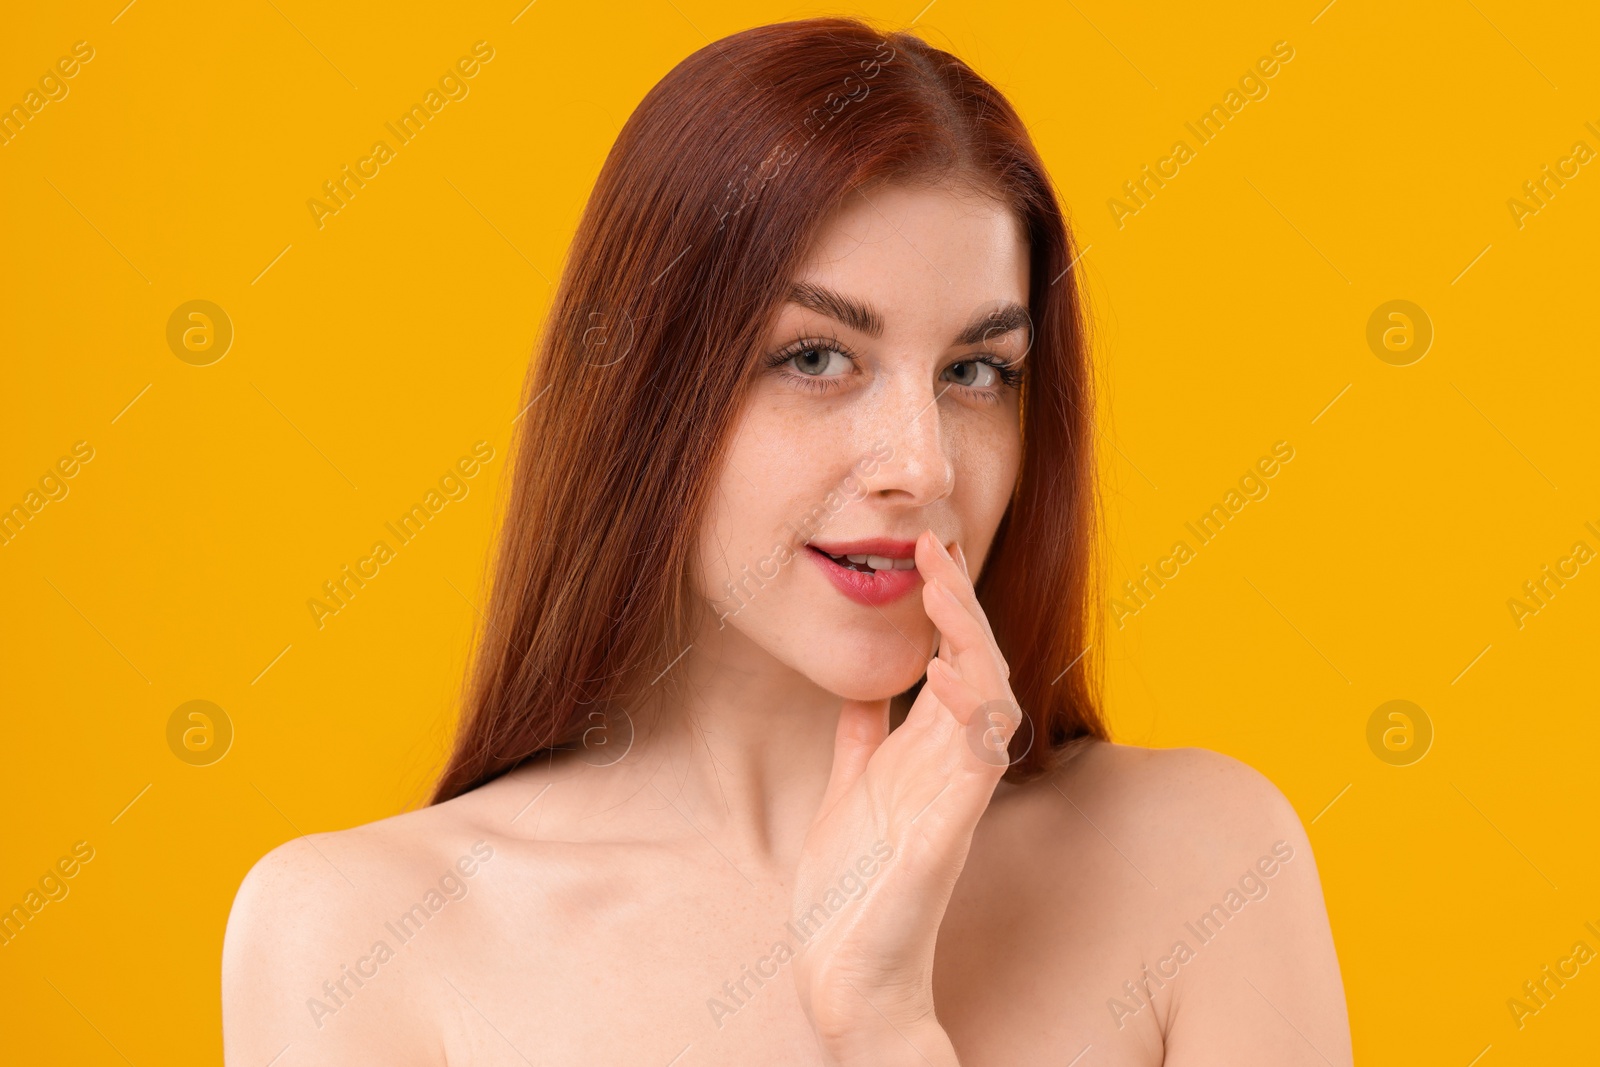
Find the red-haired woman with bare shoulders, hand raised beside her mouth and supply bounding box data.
[224,19,1350,1067]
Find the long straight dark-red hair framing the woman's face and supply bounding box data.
[432,18,1107,803]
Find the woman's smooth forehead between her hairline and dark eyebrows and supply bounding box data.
[789,184,1029,331]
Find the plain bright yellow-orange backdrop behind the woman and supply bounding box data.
[0,0,1600,1067]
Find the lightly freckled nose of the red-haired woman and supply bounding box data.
[866,381,955,507]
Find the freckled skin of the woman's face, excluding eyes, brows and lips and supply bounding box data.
[701,181,1029,699]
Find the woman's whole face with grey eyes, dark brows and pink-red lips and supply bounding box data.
[699,178,1032,699]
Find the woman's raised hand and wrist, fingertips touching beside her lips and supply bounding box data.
[794,531,1021,1067]
